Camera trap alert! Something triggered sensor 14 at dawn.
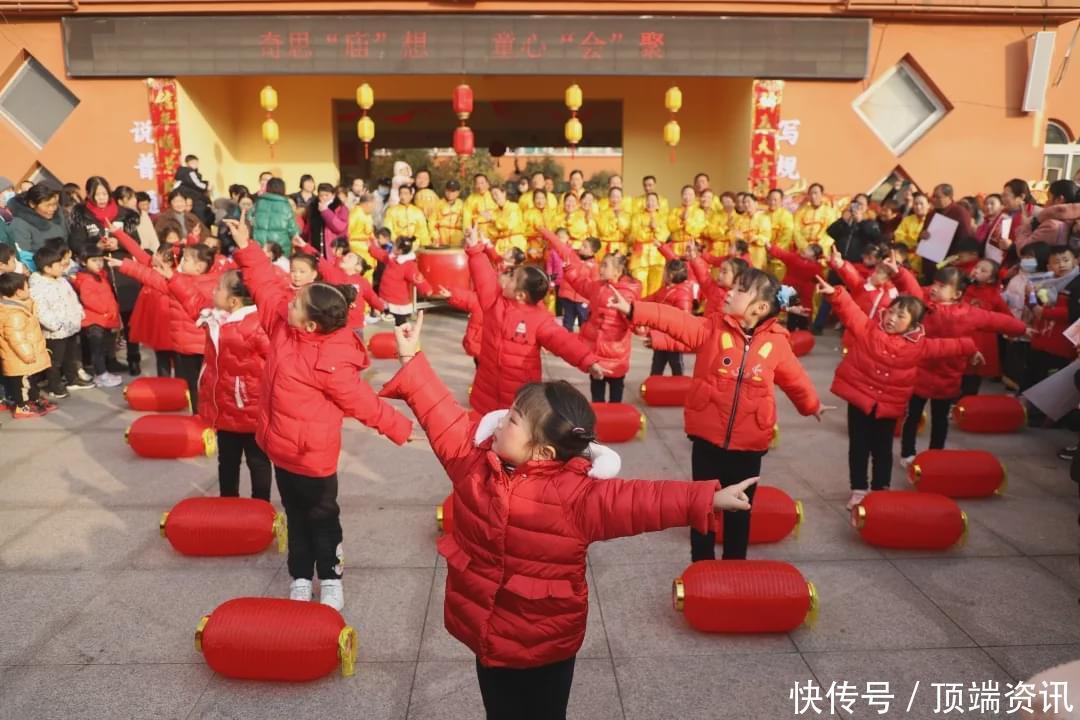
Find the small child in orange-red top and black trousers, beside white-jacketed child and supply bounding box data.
[71,249,123,388]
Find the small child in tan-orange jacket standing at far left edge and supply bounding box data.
[0,272,56,420]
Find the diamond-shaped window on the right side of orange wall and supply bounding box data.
[852,60,949,155]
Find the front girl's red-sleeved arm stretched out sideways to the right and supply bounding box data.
[568,477,758,542]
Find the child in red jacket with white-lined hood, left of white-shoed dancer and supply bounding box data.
[168,270,270,501]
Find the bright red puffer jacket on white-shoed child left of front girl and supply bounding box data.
[232,243,413,477]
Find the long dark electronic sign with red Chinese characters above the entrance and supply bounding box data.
[63,14,870,80]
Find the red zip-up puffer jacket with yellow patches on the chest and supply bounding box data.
[632,302,821,451]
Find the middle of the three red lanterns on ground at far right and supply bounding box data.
[907,450,1005,498]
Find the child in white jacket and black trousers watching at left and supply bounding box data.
[30,245,86,399]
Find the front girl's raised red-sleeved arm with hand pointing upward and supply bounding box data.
[379,312,476,474]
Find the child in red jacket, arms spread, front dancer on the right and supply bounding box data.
[818,277,975,510]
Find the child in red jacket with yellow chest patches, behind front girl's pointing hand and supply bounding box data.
[609,268,816,561]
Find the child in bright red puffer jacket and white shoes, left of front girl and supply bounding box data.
[225,220,413,610]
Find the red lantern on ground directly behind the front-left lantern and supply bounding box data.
[159,498,288,557]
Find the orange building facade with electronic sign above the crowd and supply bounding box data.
[0,0,1080,196]
